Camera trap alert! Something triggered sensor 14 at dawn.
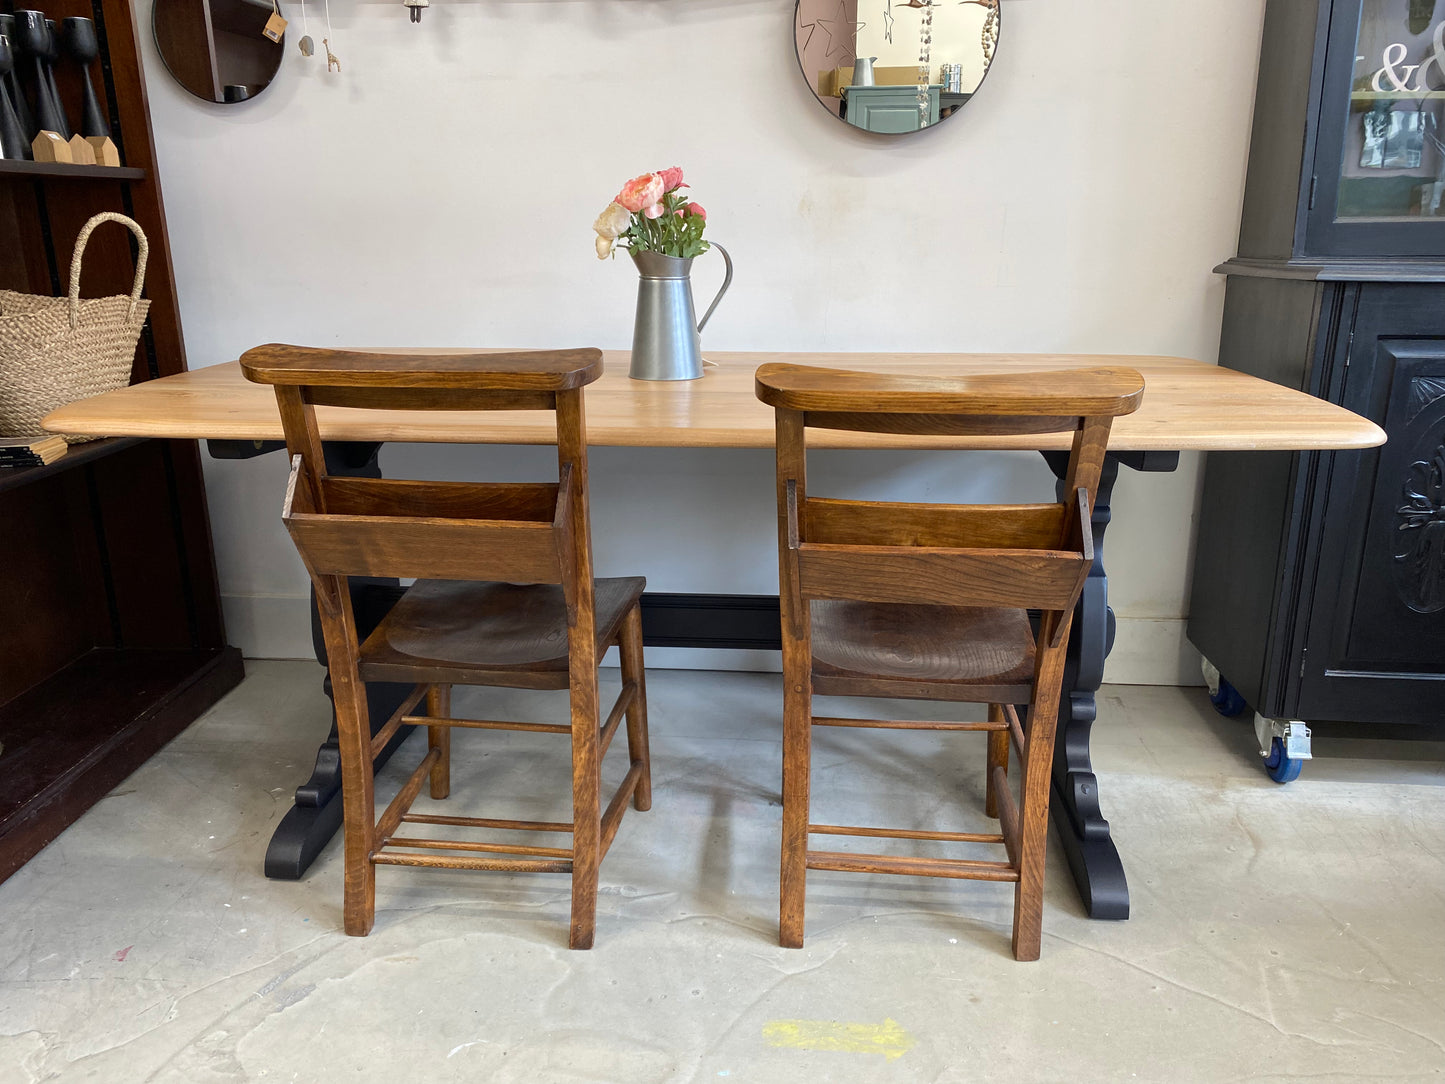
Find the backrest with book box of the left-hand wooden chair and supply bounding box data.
[241,344,603,623]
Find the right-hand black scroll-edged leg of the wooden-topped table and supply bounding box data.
[1043,452,1179,919]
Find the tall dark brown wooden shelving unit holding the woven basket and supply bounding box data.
[0,0,241,880]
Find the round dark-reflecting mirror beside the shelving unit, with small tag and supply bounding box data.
[150,0,285,103]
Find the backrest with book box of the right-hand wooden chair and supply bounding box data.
[756,364,1144,646]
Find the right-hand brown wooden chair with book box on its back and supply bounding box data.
[756,364,1144,960]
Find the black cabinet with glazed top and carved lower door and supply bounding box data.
[1189,0,1445,723]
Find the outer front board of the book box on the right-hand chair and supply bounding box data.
[798,542,1090,610]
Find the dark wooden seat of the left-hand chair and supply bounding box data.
[360,577,647,689]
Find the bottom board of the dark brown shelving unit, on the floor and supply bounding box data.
[0,648,243,880]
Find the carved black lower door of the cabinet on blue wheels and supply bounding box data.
[1298,286,1445,723]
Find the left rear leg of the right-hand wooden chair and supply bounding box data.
[777,650,812,948]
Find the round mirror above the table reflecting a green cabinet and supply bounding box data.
[793,0,998,134]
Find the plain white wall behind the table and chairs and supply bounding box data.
[146,0,1263,682]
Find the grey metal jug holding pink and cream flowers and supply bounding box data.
[627,243,733,380]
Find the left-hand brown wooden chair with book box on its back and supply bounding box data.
[241,345,652,948]
